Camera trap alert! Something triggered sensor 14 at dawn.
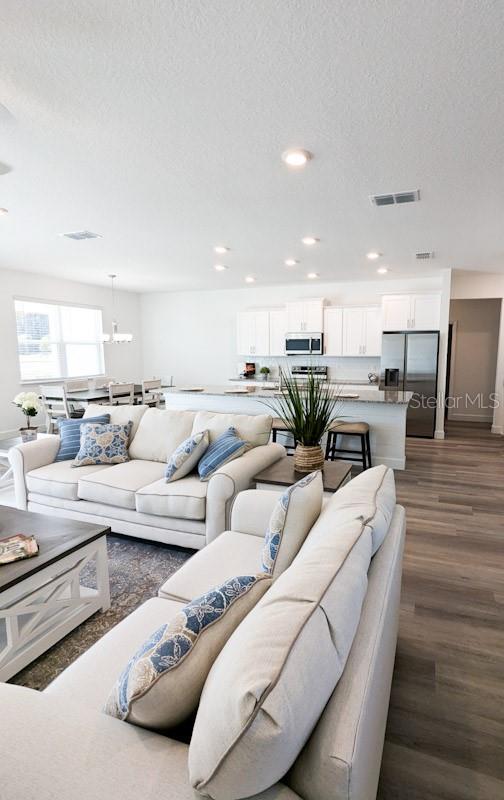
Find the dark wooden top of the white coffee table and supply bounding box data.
[0,506,110,591]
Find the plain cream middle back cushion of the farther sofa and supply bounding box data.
[130,408,195,463]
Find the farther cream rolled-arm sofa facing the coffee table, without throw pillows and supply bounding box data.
[9,405,285,550]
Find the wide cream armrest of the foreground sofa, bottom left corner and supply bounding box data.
[0,684,193,800]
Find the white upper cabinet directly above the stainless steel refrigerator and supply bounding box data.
[382,294,441,331]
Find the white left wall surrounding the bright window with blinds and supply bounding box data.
[0,270,143,436]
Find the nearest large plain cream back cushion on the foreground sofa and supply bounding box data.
[189,520,371,800]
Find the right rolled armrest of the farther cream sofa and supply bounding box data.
[206,444,285,544]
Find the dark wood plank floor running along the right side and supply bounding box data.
[378,423,504,800]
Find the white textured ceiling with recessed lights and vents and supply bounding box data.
[0,0,504,291]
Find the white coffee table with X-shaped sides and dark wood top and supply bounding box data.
[0,506,110,681]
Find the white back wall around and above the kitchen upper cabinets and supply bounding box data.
[141,276,442,386]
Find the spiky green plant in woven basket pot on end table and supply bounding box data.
[263,368,339,472]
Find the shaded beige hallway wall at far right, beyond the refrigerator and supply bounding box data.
[448,298,501,422]
